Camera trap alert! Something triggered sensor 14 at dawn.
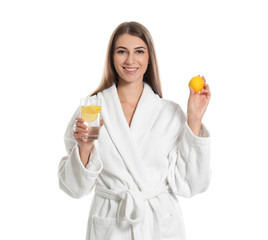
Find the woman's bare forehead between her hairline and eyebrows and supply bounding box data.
[115,33,147,48]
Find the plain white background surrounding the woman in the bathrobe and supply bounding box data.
[0,0,268,240]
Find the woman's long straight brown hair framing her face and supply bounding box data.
[91,22,162,98]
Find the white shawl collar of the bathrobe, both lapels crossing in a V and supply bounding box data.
[99,84,160,191]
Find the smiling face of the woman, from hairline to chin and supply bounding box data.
[113,34,149,83]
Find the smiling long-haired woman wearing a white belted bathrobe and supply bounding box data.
[59,22,210,240]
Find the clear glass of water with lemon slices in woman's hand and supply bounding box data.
[80,97,101,140]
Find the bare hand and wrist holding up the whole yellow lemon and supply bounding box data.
[187,76,211,133]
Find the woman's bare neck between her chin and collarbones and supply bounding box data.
[117,81,143,104]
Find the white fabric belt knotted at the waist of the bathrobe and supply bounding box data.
[95,185,170,226]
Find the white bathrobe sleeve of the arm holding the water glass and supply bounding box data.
[58,109,103,198]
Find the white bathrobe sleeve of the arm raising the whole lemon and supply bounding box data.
[168,104,210,197]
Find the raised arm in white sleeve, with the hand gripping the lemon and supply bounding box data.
[168,77,211,197]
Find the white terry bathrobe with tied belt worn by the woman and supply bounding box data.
[59,84,210,240]
